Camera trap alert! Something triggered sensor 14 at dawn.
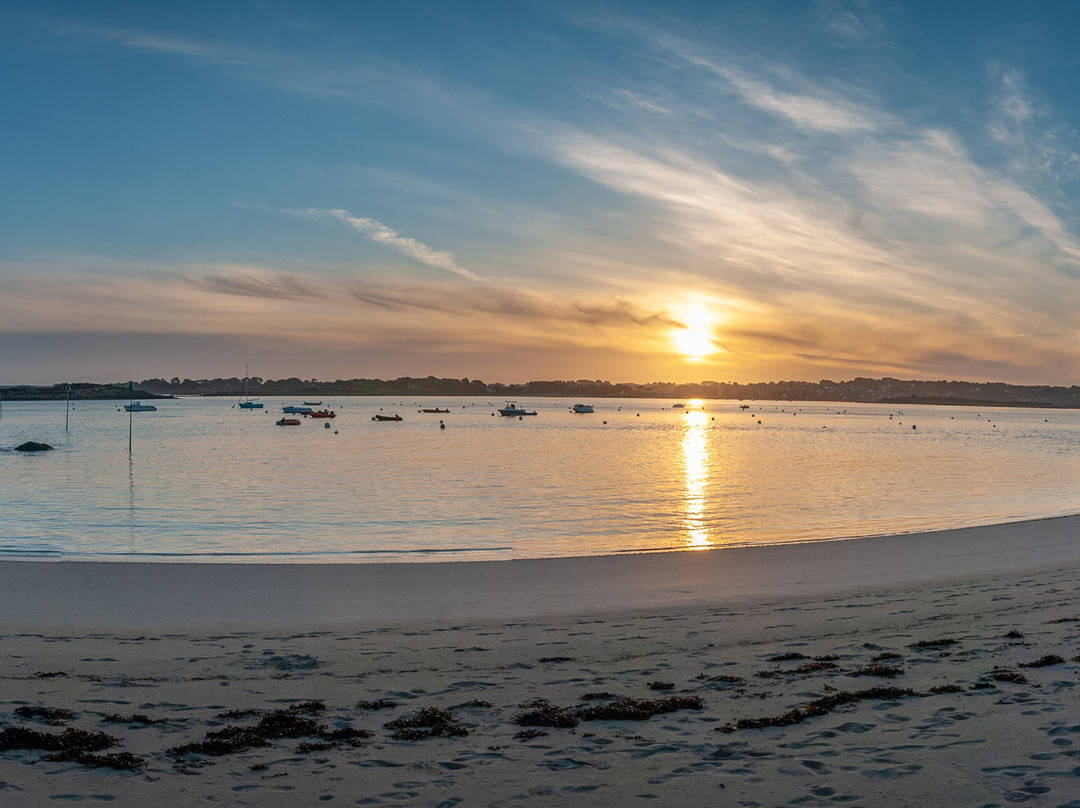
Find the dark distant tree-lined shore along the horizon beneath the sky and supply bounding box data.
[6,376,1080,408]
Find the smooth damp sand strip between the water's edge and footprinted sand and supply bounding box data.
[0,515,1080,630]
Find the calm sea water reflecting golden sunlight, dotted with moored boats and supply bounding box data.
[0,398,1080,562]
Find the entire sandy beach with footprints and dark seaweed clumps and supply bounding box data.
[0,516,1080,806]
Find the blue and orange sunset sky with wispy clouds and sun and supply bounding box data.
[0,0,1080,385]
